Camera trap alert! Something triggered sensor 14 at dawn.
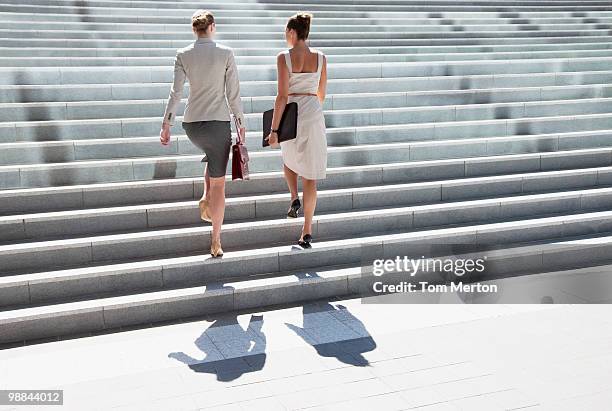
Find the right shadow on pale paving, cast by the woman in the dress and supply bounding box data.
[285,303,376,367]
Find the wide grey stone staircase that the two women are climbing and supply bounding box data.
[0,0,612,344]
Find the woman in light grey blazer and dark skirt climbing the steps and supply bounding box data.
[160,10,246,257]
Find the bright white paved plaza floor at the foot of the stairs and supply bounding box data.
[0,290,612,411]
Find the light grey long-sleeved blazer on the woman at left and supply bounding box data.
[164,37,246,127]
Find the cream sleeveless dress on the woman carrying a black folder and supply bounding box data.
[280,50,327,180]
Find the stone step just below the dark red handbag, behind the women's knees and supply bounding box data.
[0,151,612,215]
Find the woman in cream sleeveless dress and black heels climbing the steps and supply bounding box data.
[267,13,327,248]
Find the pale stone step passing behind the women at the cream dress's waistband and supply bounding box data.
[0,71,612,104]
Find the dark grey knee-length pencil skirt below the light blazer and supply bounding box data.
[183,121,232,177]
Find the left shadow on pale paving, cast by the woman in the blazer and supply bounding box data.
[168,315,266,382]
